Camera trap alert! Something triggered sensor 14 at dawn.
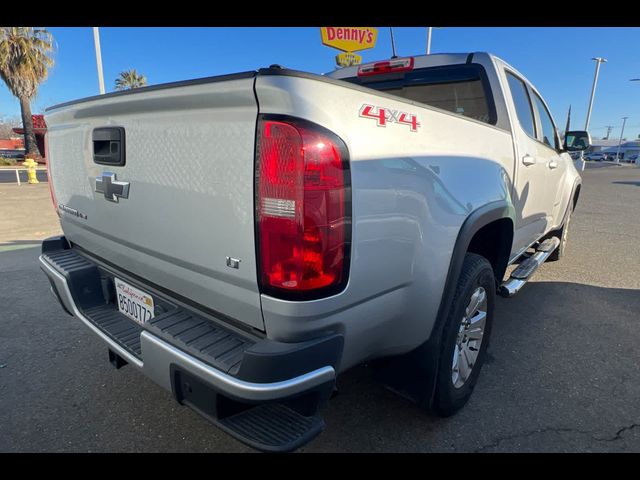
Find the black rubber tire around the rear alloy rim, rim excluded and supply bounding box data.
[433,253,496,417]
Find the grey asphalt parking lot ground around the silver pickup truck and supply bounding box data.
[0,166,640,452]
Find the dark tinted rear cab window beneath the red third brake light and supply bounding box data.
[343,63,497,125]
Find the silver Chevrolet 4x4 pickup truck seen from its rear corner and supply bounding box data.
[40,53,585,451]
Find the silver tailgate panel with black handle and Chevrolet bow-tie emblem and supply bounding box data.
[46,72,264,330]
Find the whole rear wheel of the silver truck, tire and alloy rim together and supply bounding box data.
[433,253,496,417]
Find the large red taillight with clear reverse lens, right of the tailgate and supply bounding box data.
[256,119,351,298]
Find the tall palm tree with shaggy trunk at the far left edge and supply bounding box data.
[0,27,53,158]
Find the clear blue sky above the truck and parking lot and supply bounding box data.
[0,27,640,138]
